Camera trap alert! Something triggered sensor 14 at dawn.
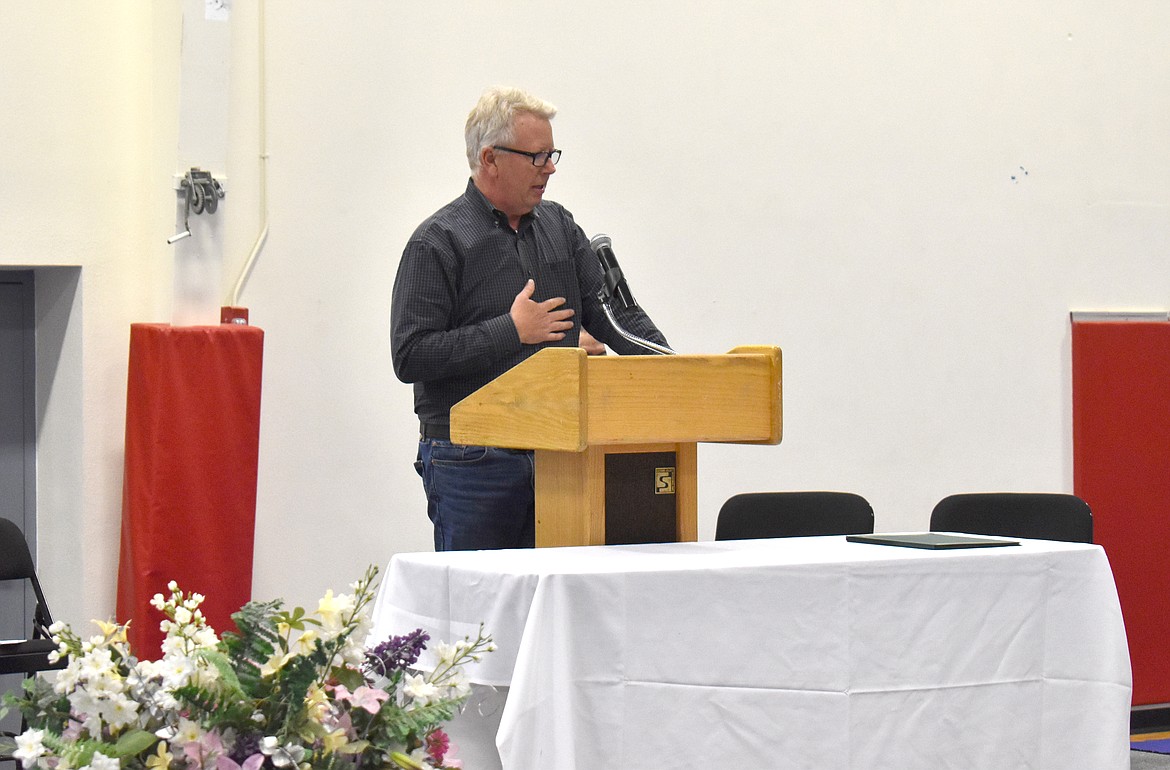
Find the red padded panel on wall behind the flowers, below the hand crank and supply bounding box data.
[117,324,264,659]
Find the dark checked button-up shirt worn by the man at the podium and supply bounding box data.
[390,176,666,424]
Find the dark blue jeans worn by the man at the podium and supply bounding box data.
[414,439,536,551]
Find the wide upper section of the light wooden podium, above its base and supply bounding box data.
[450,345,783,452]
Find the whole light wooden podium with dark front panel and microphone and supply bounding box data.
[450,345,783,546]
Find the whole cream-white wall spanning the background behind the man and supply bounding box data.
[0,0,1170,620]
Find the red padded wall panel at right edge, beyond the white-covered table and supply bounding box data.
[1073,322,1170,706]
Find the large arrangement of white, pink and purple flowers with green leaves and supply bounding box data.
[6,568,495,770]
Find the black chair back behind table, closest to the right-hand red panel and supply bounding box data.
[930,491,1093,543]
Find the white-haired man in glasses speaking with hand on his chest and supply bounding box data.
[390,88,667,550]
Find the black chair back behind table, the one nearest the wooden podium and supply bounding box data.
[715,491,874,541]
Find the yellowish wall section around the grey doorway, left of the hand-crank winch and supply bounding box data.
[0,2,174,619]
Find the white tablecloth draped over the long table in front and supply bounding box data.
[374,537,1130,770]
